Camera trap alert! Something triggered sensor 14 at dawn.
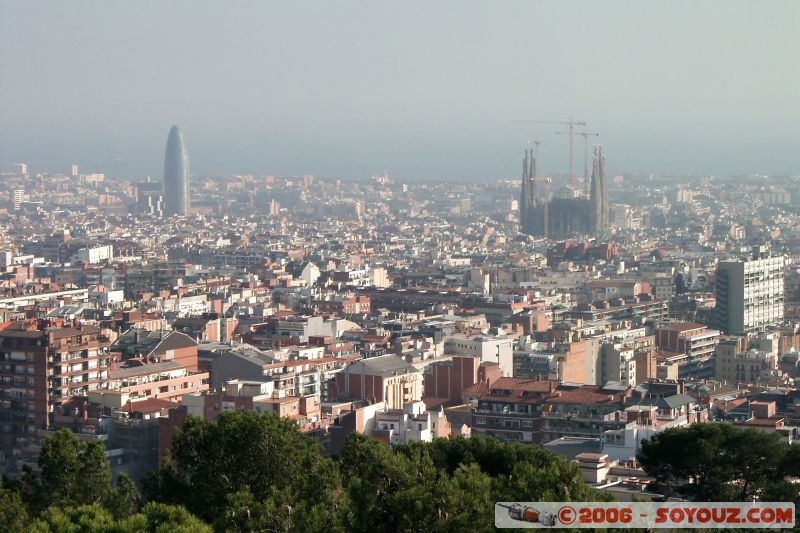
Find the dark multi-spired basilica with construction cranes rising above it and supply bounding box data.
[520,146,608,239]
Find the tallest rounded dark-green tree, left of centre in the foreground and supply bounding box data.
[146,411,339,522]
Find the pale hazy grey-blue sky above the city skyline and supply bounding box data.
[0,0,800,179]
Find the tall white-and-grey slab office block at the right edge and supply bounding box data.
[714,247,784,335]
